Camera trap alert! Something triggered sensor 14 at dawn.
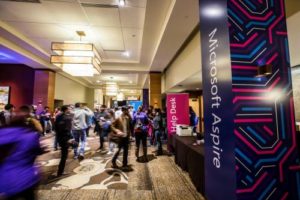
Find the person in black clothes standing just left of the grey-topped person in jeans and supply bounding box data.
[55,105,73,176]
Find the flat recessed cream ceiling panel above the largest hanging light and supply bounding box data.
[0,0,146,62]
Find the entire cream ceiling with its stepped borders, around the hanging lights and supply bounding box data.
[0,0,300,93]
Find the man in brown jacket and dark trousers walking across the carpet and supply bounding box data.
[111,107,131,170]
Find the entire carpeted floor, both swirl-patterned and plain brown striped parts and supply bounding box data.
[37,135,204,200]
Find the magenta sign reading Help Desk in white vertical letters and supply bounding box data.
[167,93,190,135]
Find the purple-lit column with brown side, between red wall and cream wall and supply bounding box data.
[33,70,55,110]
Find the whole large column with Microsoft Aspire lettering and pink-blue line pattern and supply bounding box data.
[199,0,300,200]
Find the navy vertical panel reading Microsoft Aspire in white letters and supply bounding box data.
[199,0,236,200]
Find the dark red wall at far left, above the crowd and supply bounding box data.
[0,64,34,107]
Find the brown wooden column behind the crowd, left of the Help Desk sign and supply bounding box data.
[149,72,161,108]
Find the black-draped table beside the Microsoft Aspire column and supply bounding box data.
[170,135,204,195]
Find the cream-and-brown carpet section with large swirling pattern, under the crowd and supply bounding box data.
[38,135,128,190]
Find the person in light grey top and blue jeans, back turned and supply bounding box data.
[72,103,89,160]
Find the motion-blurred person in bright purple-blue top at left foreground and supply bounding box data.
[0,106,44,200]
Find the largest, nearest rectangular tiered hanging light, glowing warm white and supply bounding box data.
[50,31,101,76]
